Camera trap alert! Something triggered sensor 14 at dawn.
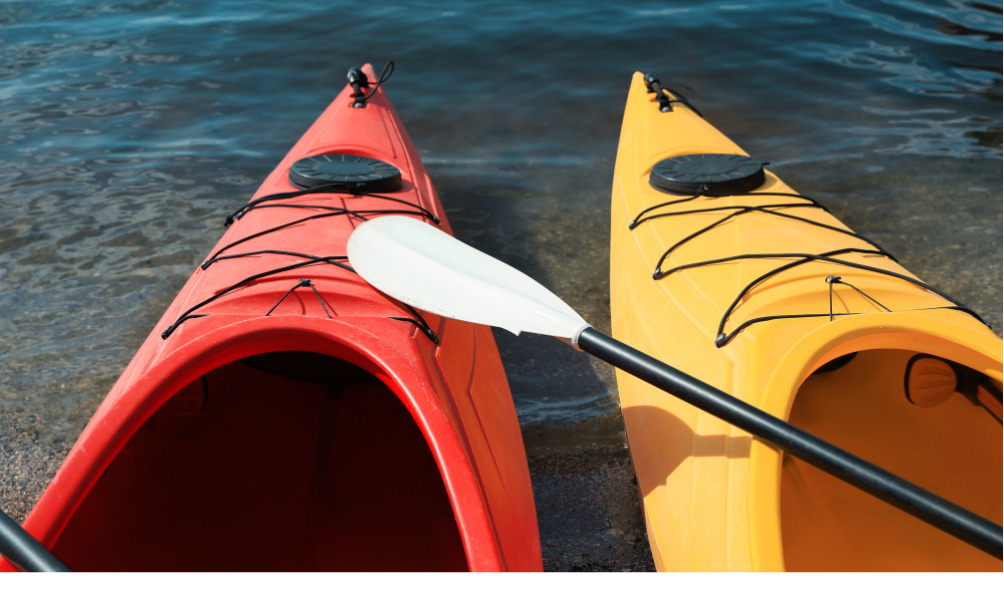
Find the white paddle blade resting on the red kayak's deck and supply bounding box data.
[348,216,589,344]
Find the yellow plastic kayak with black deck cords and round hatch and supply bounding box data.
[610,72,1004,572]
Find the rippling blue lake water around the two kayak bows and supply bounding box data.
[0,0,1002,449]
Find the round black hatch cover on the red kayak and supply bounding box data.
[289,154,401,193]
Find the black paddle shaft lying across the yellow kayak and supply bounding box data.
[578,328,1004,558]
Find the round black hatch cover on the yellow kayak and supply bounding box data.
[649,154,764,195]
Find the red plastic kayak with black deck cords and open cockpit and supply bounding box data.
[0,65,541,571]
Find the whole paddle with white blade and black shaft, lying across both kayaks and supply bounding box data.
[348,216,1004,558]
